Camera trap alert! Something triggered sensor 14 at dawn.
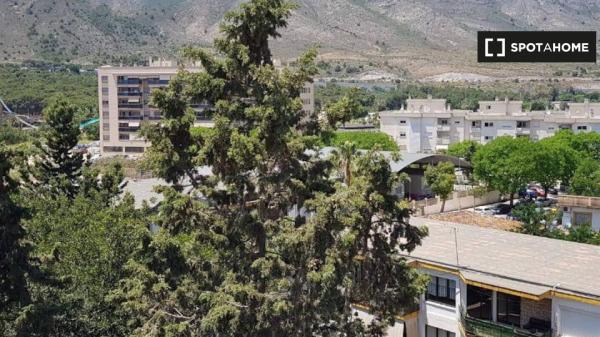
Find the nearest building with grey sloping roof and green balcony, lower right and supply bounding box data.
[359,218,600,337]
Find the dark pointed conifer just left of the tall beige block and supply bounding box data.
[33,97,83,198]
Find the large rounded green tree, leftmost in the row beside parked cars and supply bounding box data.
[473,136,535,206]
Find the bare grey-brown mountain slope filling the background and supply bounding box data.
[0,0,600,76]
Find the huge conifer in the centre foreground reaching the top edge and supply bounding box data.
[112,0,425,337]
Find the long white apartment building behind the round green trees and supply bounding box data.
[379,96,600,153]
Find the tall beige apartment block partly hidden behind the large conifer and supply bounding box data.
[97,61,314,157]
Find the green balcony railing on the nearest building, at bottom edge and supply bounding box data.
[463,316,552,337]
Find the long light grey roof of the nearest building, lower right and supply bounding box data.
[402,217,600,300]
